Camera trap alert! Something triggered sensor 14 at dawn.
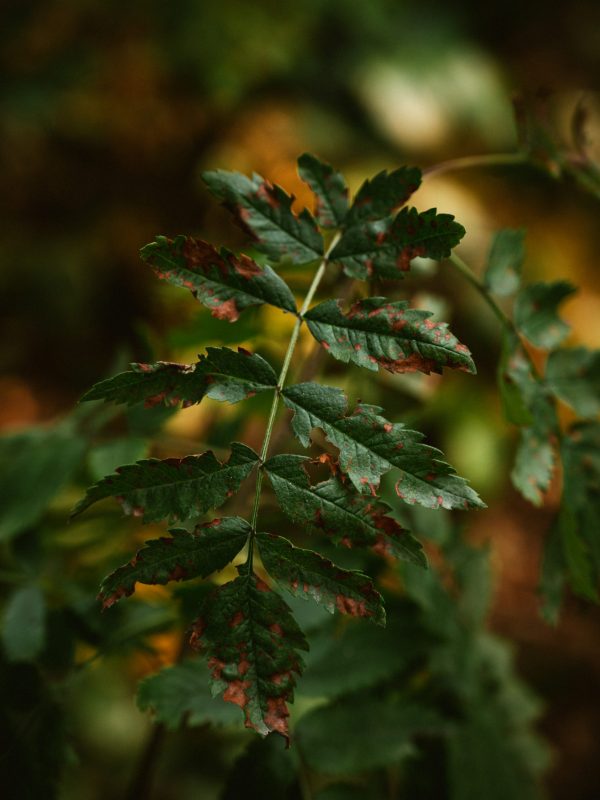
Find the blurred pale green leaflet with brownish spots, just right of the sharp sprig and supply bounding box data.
[510,427,556,506]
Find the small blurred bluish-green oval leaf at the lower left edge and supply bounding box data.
[2,584,46,662]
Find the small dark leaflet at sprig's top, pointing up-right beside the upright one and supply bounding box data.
[345,162,421,228]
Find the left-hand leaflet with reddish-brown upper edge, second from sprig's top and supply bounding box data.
[141,236,296,322]
